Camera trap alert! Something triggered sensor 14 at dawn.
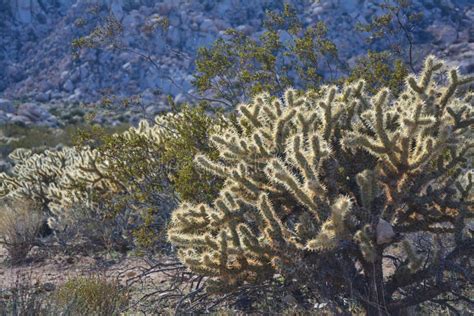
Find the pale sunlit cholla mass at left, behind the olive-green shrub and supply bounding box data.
[0,114,184,231]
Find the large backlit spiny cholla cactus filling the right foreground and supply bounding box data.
[168,57,474,315]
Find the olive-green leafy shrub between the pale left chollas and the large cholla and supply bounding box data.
[67,106,225,250]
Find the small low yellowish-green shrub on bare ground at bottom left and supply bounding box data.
[52,276,128,316]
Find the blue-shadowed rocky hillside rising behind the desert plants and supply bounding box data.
[0,0,474,126]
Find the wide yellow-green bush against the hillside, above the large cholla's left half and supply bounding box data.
[193,4,342,108]
